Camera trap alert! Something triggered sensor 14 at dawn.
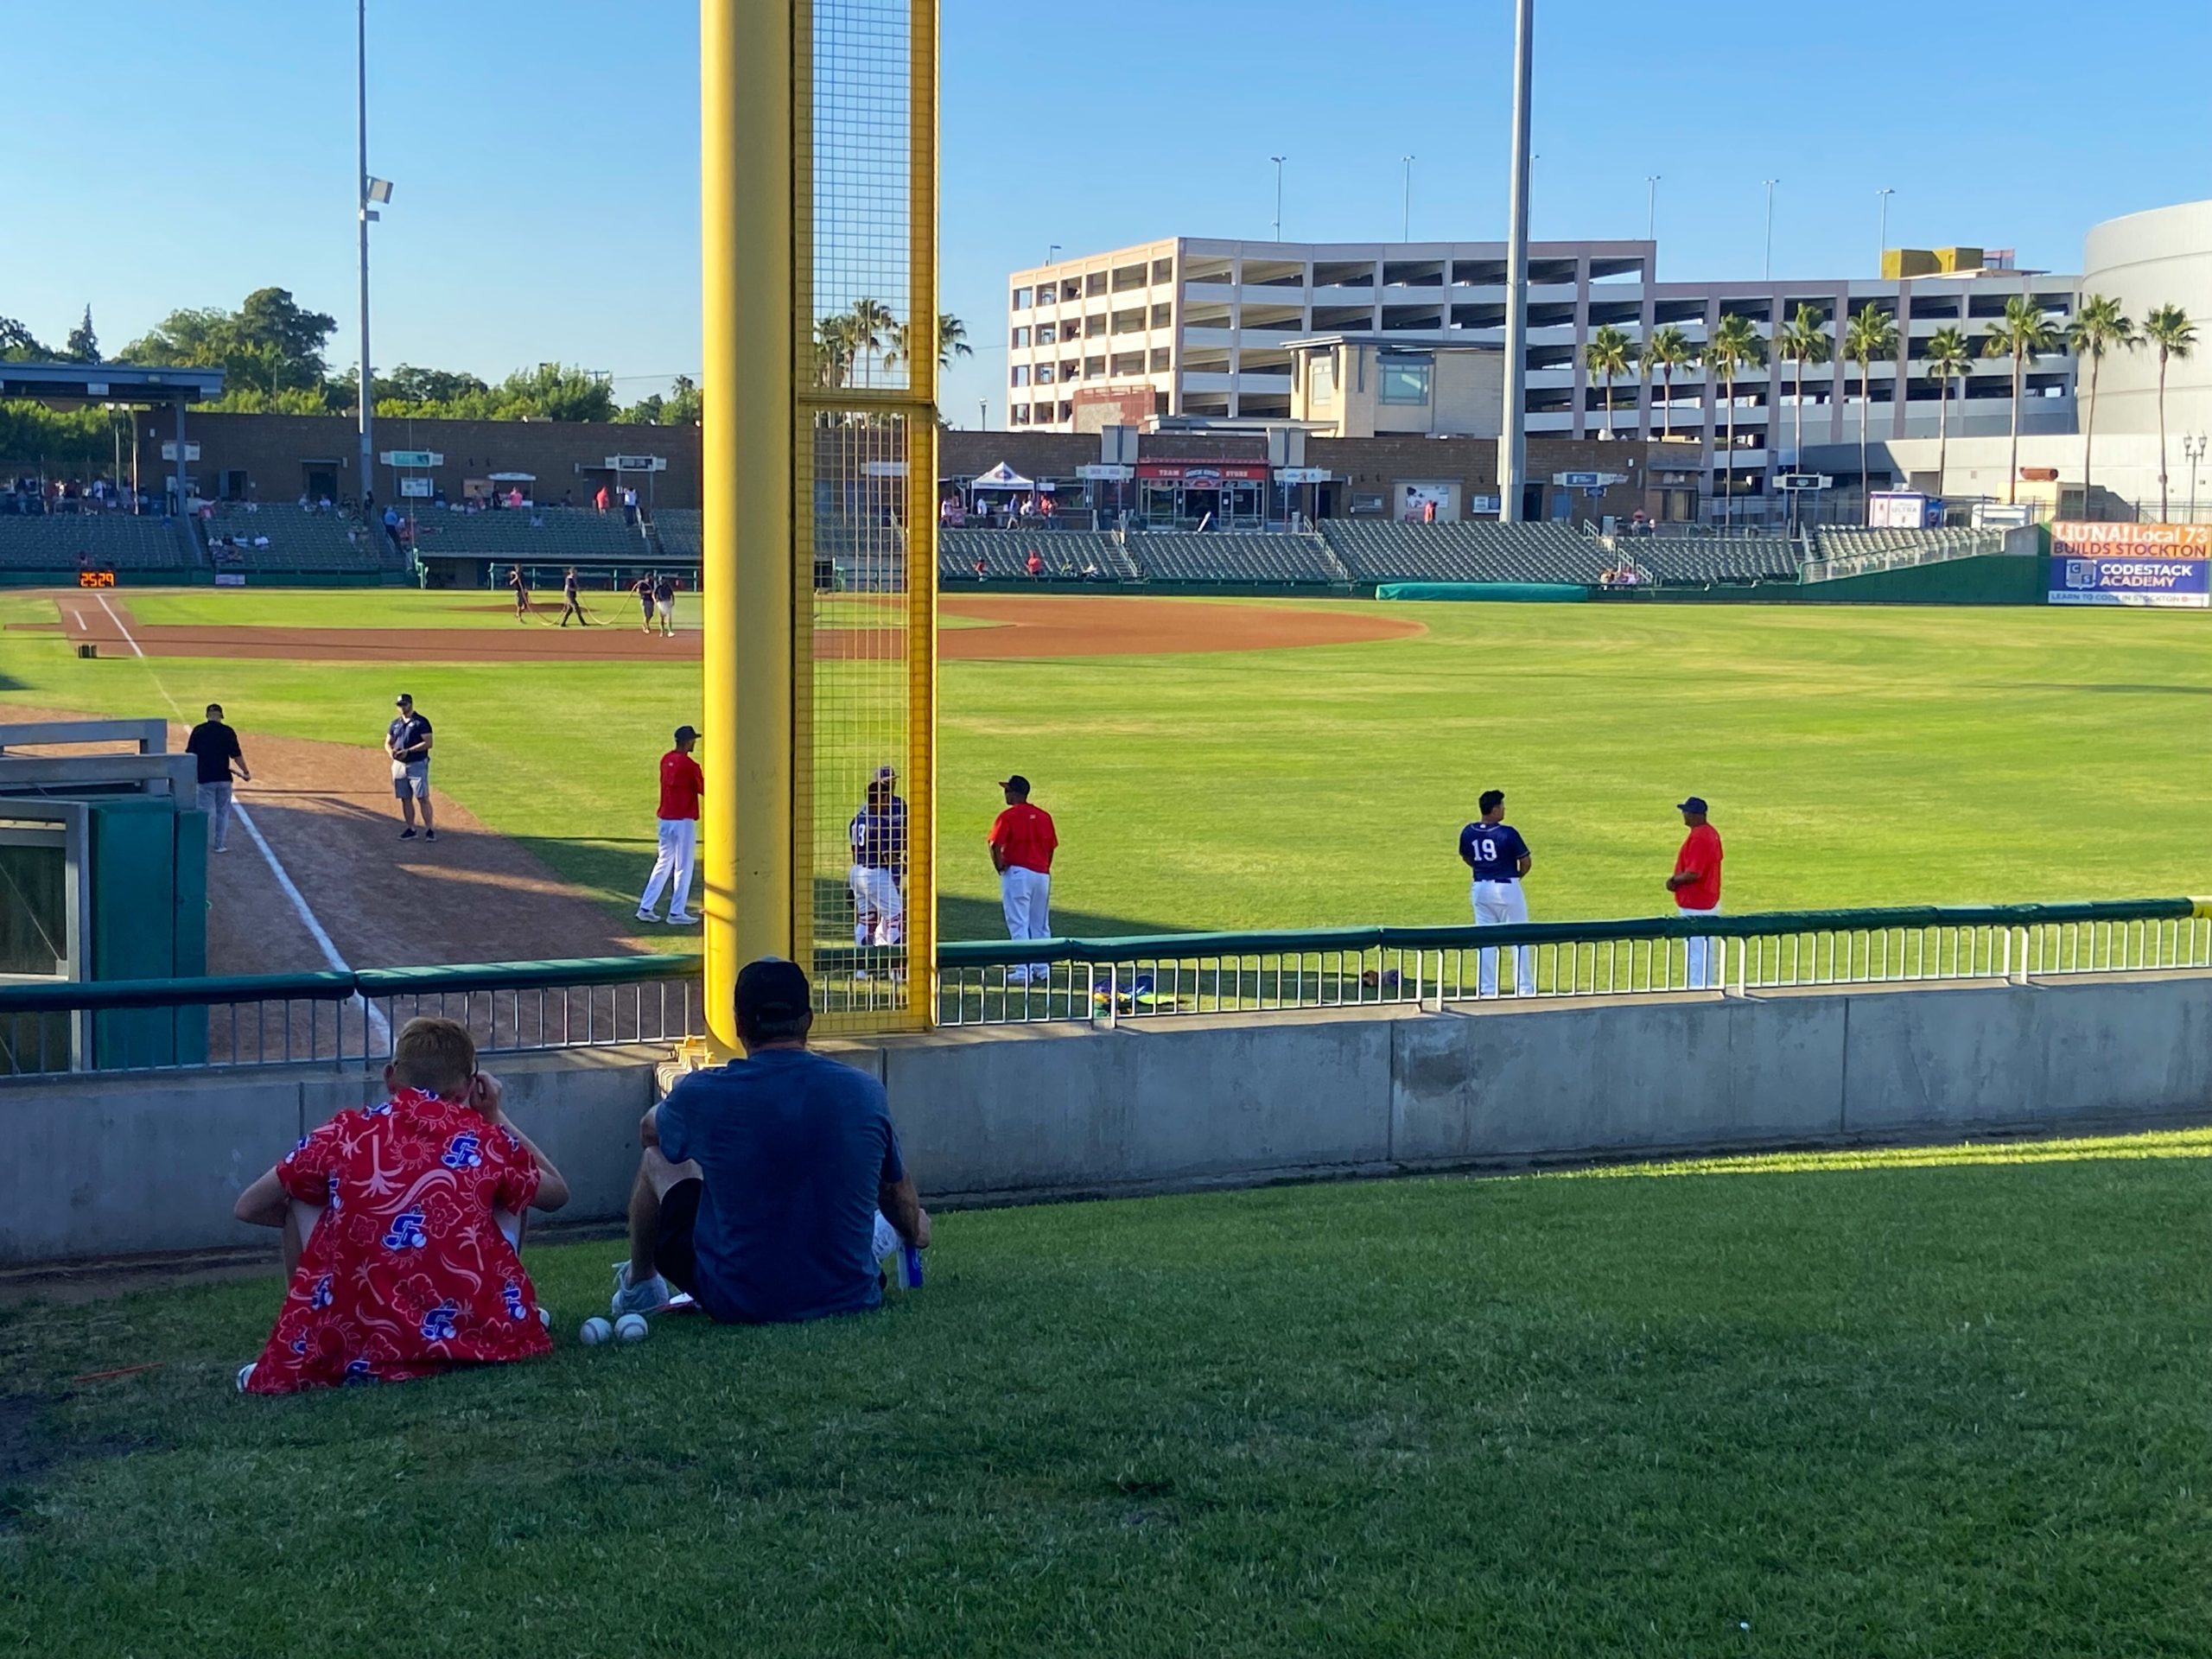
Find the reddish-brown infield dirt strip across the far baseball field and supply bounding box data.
[21,593,1422,661]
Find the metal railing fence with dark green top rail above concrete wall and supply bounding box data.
[0,898,2212,1077]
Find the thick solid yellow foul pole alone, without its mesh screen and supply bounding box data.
[699,0,794,1053]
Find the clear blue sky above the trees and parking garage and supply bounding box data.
[0,0,2212,425]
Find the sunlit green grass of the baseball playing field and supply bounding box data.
[0,593,2212,938]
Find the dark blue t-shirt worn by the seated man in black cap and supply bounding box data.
[659,1048,907,1323]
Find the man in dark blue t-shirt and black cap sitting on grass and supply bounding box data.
[613,957,929,1325]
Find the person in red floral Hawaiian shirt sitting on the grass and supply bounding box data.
[237,1020,569,1394]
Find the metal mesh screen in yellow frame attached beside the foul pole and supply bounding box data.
[794,0,938,1031]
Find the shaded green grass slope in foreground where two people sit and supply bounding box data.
[0,1133,2212,1659]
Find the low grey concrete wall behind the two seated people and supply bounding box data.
[0,973,2212,1265]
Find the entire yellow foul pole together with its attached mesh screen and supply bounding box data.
[702,0,938,1048]
